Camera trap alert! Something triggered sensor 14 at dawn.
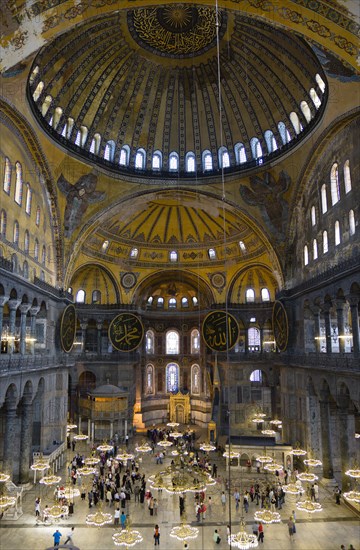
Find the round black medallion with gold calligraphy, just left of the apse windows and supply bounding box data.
[109,313,144,351]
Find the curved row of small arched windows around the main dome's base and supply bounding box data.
[30,71,325,174]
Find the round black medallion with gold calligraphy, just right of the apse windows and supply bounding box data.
[202,311,239,351]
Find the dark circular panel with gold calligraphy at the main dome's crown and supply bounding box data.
[128,4,226,58]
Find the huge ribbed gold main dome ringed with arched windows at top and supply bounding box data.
[28,4,327,183]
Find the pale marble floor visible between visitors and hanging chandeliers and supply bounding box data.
[0,444,360,550]
